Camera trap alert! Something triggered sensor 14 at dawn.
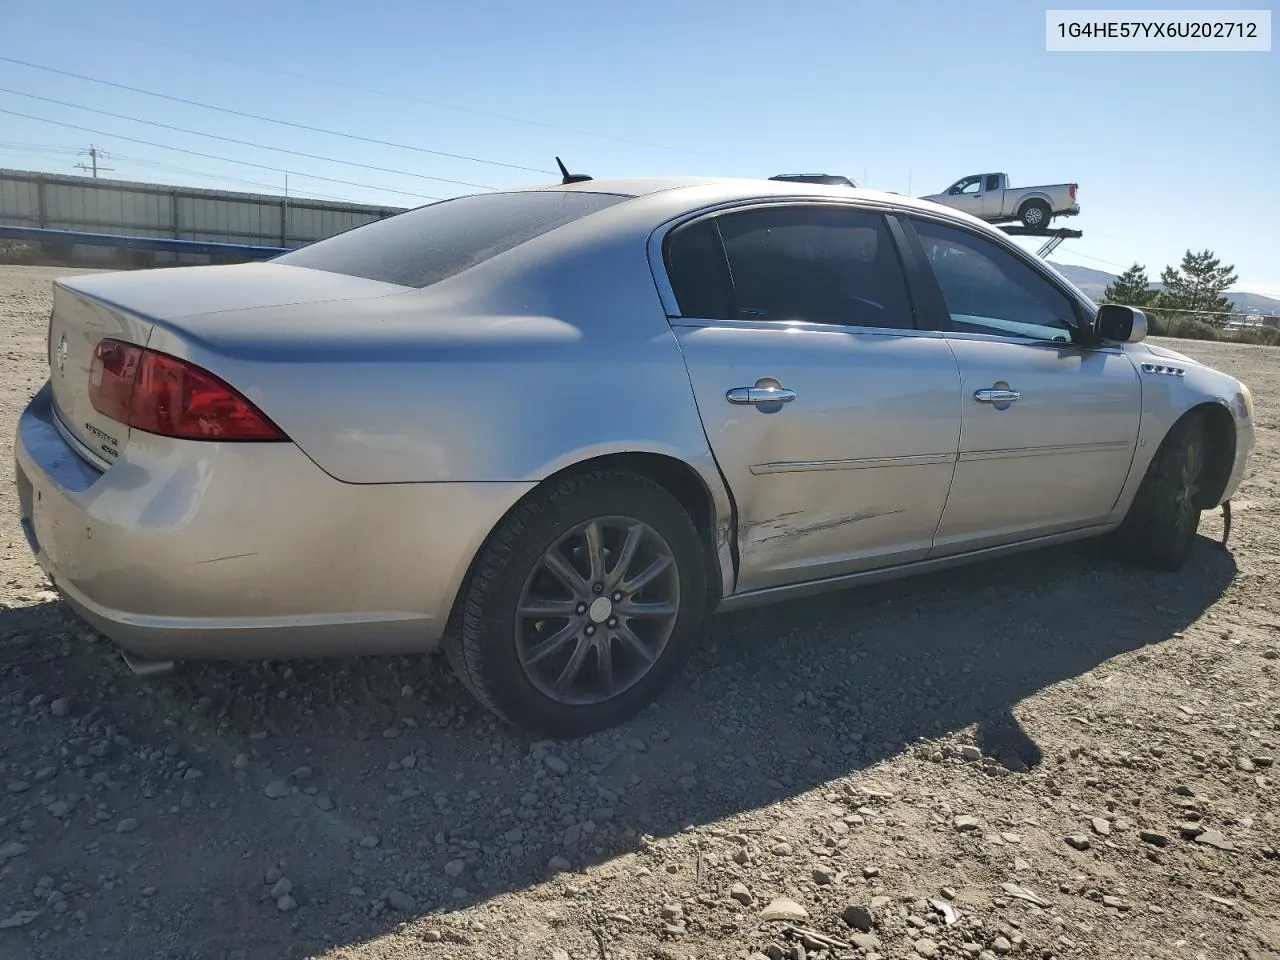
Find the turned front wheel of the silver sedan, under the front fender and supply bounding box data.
[1114,416,1208,572]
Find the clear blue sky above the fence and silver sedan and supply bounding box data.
[0,0,1280,297]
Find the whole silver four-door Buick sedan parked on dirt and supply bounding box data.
[17,178,1253,736]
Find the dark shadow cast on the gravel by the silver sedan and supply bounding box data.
[0,538,1236,956]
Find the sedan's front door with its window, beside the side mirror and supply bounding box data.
[913,219,1142,556]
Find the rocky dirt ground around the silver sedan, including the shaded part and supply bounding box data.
[0,268,1280,960]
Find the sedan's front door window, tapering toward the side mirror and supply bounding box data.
[914,220,1075,340]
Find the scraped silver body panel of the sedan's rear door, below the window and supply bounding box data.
[677,326,960,591]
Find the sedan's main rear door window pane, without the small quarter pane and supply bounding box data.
[717,206,914,328]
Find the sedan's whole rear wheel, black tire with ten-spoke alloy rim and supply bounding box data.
[444,470,705,737]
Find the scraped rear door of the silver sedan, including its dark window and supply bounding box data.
[663,202,960,593]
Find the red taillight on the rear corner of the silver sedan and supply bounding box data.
[88,340,288,440]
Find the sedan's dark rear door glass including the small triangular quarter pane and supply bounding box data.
[668,205,915,329]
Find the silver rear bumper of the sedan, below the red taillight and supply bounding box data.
[15,385,531,659]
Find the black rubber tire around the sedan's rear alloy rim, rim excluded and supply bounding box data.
[443,470,707,739]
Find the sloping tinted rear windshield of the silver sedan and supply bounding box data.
[274,191,631,287]
